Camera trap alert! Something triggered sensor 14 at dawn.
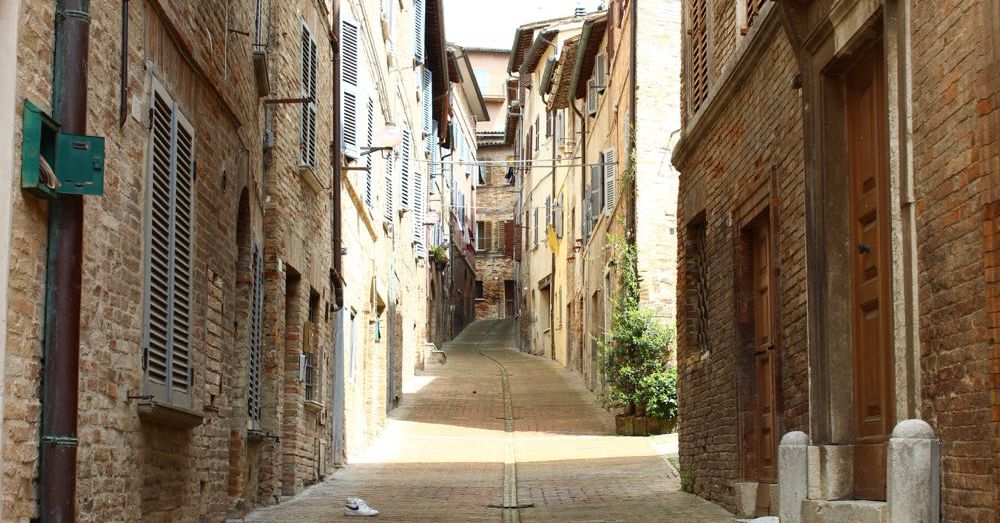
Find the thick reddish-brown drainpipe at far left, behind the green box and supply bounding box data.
[38,0,90,523]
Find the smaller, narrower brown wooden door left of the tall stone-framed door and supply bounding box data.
[750,212,778,483]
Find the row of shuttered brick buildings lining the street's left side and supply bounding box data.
[0,0,450,521]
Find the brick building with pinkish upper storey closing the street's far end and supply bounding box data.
[465,48,519,319]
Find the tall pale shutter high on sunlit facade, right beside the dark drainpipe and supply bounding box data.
[340,17,362,159]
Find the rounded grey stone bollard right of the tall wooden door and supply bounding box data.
[886,419,941,523]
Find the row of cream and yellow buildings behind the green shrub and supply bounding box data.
[511,0,680,390]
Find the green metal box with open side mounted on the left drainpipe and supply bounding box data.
[21,100,104,198]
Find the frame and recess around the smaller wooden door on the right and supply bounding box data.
[732,172,784,481]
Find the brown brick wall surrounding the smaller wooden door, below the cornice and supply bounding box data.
[677,21,808,510]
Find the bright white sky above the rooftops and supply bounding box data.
[444,0,604,49]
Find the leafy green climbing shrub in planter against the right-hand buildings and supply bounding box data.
[597,238,677,436]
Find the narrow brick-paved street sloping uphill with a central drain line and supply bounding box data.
[247,321,732,523]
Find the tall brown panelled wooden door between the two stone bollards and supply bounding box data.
[846,43,895,500]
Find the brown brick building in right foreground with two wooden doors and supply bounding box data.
[673,0,1000,521]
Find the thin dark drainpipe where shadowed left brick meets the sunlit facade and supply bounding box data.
[330,0,344,311]
